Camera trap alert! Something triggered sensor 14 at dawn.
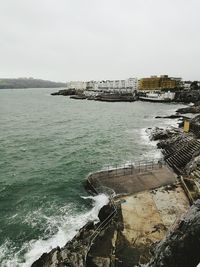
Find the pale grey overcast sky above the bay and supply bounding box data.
[0,0,200,81]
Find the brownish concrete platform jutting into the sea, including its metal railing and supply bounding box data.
[87,161,176,195]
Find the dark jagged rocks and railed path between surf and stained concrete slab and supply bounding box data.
[32,202,122,267]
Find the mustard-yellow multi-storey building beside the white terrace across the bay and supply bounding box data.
[139,75,181,91]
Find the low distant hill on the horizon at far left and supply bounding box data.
[0,78,67,89]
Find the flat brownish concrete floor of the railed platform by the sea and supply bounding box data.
[90,166,176,194]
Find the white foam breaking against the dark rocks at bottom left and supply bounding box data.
[0,194,109,267]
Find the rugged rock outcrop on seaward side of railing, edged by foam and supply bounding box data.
[31,204,116,267]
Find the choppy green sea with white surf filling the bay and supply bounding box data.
[0,89,186,267]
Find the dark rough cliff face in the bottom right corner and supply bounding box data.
[147,200,200,267]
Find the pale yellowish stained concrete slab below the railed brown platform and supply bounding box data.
[121,185,189,263]
